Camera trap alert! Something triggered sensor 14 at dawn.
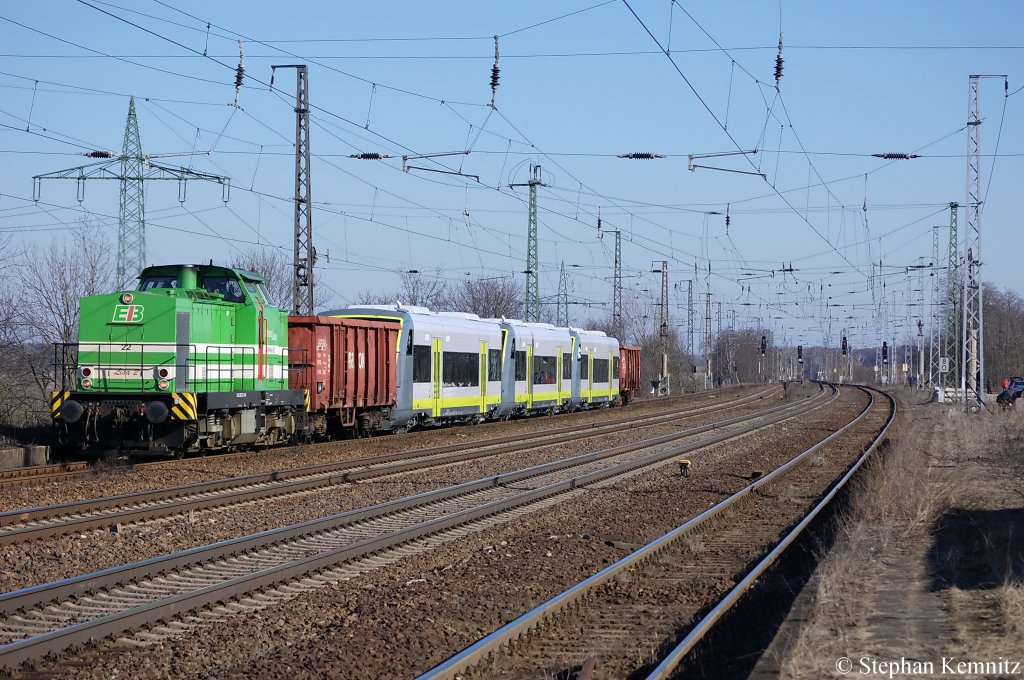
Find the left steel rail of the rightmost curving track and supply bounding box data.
[419,388,873,680]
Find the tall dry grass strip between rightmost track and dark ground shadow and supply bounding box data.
[780,405,987,678]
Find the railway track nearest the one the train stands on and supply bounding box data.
[0,389,776,545]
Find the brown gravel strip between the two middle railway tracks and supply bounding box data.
[0,387,769,591]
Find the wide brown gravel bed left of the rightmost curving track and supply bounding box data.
[40,390,866,679]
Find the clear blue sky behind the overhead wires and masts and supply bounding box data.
[0,0,1024,347]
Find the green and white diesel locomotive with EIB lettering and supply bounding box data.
[51,265,305,455]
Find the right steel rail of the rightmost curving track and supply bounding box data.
[647,385,896,680]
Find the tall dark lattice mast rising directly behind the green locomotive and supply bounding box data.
[270,63,316,316]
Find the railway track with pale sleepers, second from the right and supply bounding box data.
[0,389,838,668]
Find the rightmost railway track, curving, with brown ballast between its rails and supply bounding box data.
[421,388,896,680]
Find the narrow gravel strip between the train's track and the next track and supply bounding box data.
[0,385,765,512]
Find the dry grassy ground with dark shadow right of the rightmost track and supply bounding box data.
[769,393,1024,680]
